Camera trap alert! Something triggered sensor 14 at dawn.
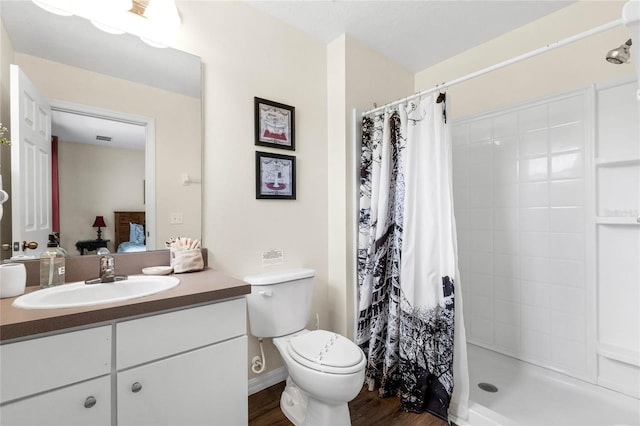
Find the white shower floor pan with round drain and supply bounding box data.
[452,344,640,426]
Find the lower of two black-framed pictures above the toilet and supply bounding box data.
[256,151,296,200]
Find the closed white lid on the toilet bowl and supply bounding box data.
[288,330,364,374]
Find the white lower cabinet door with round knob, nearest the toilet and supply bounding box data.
[117,336,248,426]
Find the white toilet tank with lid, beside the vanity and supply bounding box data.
[244,269,315,337]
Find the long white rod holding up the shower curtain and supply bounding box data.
[362,18,624,117]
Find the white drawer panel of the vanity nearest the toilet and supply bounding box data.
[116,298,246,370]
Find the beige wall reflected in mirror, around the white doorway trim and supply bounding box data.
[15,53,202,248]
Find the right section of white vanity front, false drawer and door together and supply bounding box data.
[116,298,248,426]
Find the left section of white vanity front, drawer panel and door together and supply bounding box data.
[0,326,112,426]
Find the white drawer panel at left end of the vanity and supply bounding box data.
[0,326,111,402]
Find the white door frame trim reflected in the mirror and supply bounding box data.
[48,99,157,250]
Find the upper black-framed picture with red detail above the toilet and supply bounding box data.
[253,98,296,151]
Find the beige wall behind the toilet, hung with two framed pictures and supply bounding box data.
[171,2,329,377]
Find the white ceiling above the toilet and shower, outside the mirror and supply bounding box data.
[247,0,574,72]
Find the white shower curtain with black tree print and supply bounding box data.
[356,96,469,421]
